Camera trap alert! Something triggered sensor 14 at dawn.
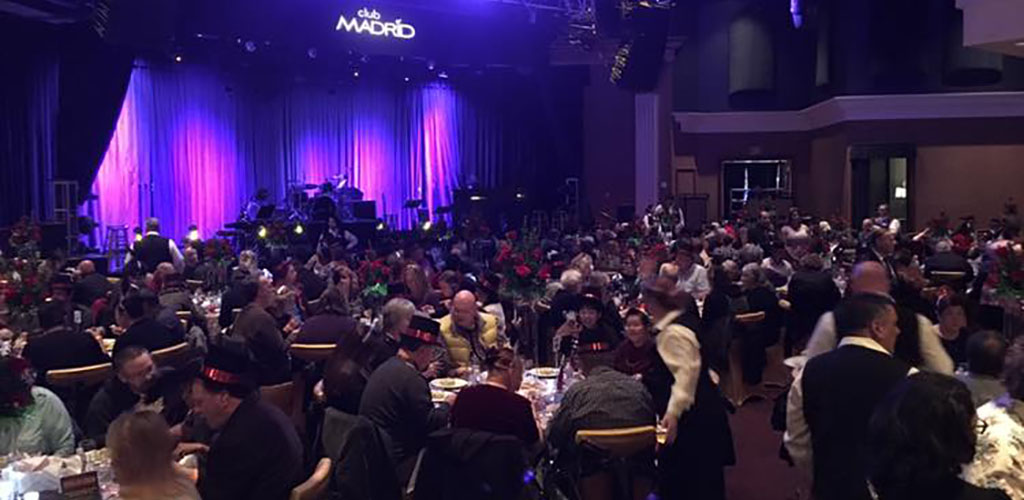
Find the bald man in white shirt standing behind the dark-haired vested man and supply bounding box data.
[804,261,954,375]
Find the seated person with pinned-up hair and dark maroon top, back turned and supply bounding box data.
[452,347,539,446]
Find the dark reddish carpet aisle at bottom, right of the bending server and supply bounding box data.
[725,400,808,500]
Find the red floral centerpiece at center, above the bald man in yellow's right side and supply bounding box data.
[493,232,552,300]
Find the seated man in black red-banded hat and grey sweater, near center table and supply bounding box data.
[359,313,453,483]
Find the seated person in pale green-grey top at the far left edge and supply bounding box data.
[0,358,75,455]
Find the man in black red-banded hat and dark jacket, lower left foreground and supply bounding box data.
[179,342,303,500]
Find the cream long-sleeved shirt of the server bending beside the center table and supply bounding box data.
[654,310,700,419]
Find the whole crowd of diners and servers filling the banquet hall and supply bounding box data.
[0,198,1024,500]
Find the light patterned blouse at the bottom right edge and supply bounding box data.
[964,395,1024,500]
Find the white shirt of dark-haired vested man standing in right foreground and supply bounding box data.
[782,336,918,477]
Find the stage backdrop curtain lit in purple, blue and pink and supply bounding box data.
[93,63,548,242]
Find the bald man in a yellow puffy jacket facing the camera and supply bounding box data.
[440,290,508,375]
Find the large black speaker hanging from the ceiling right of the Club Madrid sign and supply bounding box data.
[611,2,671,92]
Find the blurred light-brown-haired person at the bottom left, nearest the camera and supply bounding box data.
[106,411,200,500]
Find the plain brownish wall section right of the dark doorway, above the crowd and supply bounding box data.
[914,144,1024,227]
